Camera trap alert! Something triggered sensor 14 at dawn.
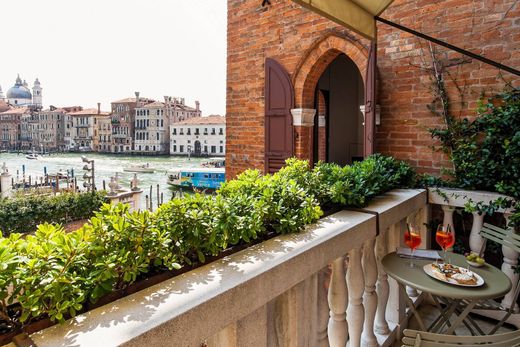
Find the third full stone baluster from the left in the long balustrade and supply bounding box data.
[361,238,377,347]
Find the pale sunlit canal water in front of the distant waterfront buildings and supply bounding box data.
[0,153,211,209]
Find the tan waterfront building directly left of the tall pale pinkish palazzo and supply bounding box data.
[111,92,154,153]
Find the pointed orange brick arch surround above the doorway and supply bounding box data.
[293,34,368,108]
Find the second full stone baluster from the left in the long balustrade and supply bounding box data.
[347,248,365,347]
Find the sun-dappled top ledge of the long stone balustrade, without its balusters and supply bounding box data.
[18,190,426,347]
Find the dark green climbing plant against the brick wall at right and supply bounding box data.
[429,88,520,226]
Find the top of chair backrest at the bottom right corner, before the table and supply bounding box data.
[402,329,520,347]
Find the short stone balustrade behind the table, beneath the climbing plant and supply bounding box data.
[428,188,520,329]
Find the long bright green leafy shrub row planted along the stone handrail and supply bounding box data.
[0,155,415,327]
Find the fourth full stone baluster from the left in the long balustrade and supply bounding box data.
[375,229,390,335]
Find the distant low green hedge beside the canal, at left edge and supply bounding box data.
[0,192,105,236]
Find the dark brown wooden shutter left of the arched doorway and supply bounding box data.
[265,58,294,173]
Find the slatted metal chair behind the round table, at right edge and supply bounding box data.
[461,223,520,335]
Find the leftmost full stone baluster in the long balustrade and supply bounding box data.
[328,257,349,347]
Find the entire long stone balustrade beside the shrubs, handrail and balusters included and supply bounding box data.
[17,190,427,347]
